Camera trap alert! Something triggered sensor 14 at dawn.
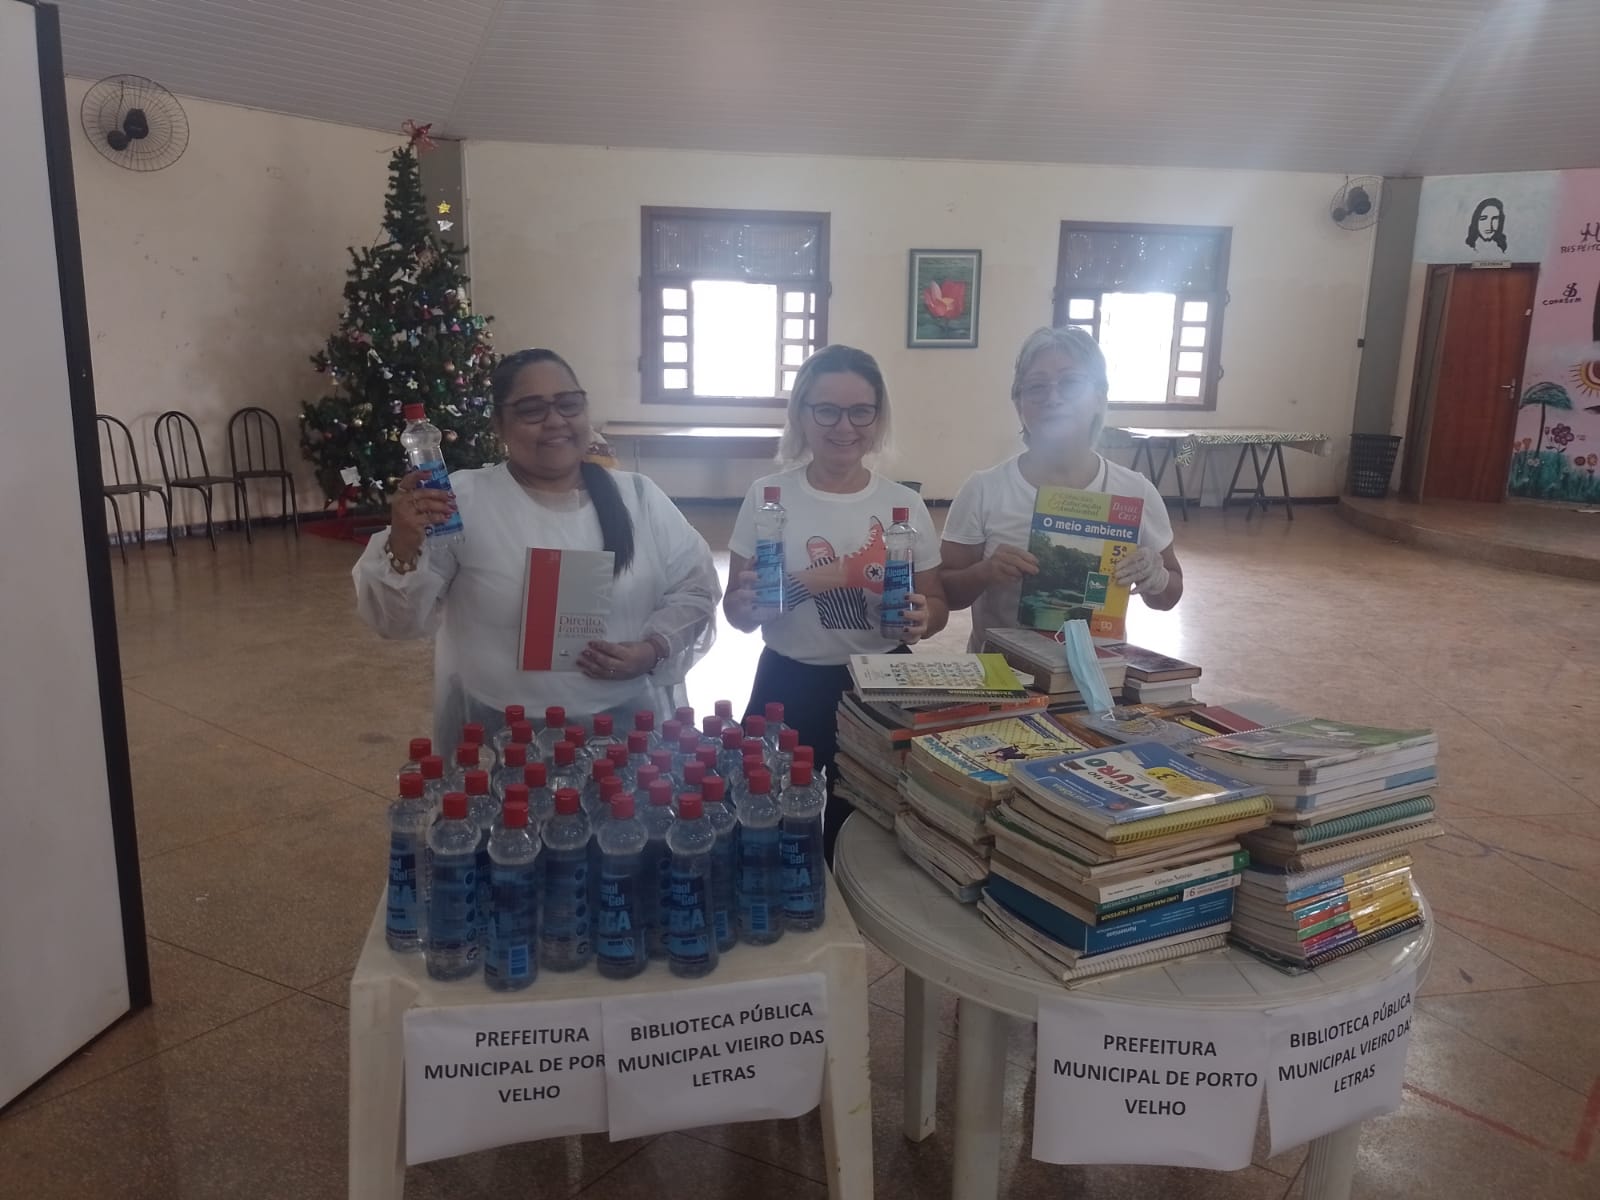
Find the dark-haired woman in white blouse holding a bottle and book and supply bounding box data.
[354,342,722,746]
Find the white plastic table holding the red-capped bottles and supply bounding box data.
[350,882,872,1200]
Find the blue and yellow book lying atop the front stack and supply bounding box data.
[1011,742,1266,826]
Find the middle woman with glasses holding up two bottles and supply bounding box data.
[723,346,949,861]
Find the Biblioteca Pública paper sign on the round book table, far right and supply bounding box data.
[1267,968,1416,1154]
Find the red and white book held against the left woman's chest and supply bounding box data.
[517,549,611,670]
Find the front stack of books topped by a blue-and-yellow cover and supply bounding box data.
[979,742,1272,986]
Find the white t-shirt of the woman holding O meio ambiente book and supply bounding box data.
[944,454,1173,653]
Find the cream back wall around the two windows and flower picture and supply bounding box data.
[467,142,1373,498]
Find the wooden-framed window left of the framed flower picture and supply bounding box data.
[638,208,829,406]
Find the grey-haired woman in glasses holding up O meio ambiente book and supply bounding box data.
[939,328,1184,651]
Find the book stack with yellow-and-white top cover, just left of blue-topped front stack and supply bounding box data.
[894,712,1086,904]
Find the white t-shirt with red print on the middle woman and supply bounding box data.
[728,466,939,666]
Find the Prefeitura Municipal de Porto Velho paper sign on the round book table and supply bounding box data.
[1034,997,1267,1171]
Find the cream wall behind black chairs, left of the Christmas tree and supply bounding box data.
[67,80,398,526]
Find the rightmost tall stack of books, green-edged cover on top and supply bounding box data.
[1190,718,1445,971]
